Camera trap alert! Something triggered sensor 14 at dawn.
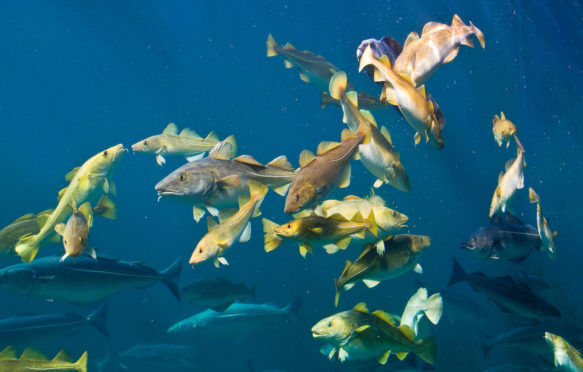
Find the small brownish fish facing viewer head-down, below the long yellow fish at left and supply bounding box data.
[55,202,97,261]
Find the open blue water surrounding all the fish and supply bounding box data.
[0,1,583,371]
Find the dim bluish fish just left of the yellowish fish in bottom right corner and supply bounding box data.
[482,326,552,360]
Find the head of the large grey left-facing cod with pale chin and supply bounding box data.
[154,167,215,200]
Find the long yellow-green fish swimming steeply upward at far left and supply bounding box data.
[14,144,125,262]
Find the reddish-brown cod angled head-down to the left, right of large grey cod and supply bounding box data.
[284,130,364,213]
